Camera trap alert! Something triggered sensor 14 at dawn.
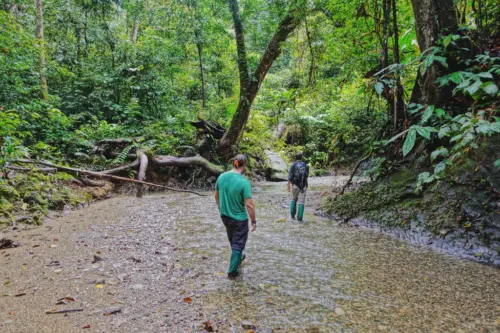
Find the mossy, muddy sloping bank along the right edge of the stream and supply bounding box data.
[318,171,500,267]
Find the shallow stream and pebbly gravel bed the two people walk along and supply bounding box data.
[0,178,500,332]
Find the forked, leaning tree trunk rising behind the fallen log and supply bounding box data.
[219,0,300,157]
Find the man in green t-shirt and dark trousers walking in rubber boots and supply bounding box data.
[215,155,257,278]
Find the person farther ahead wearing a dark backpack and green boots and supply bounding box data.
[287,153,309,221]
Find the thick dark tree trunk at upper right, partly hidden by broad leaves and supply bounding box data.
[411,0,458,106]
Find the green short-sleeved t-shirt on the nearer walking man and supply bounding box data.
[215,171,252,221]
